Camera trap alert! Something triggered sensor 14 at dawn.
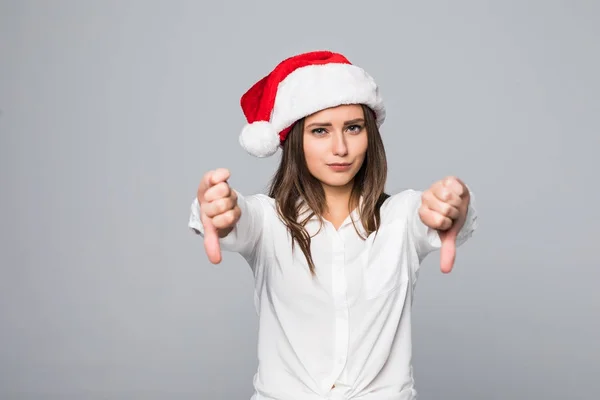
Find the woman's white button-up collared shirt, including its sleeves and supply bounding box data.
[188,190,477,400]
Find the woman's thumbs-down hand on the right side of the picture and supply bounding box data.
[419,176,471,273]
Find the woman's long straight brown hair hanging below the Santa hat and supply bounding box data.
[269,105,389,275]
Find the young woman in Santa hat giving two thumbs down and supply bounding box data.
[189,51,476,400]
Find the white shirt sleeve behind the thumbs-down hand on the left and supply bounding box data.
[188,189,264,259]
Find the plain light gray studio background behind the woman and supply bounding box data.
[0,0,600,400]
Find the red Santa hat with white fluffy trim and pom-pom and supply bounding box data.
[239,51,385,157]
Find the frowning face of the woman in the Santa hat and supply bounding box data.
[303,105,367,190]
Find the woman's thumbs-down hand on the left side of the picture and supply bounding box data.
[197,168,241,264]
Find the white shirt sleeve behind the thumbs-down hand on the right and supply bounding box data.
[408,189,477,260]
